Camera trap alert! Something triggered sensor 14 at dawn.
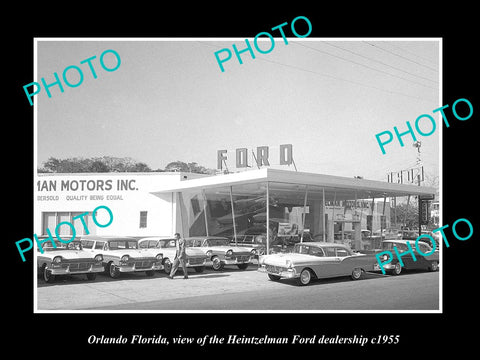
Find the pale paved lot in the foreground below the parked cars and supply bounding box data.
[37,265,439,311]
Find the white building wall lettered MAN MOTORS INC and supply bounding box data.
[34,172,202,239]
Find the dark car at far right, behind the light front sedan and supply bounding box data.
[374,240,439,275]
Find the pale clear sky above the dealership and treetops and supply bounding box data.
[33,37,443,184]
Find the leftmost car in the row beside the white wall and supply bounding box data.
[37,241,103,283]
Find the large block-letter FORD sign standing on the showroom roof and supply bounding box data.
[217,144,295,170]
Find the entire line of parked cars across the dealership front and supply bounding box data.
[37,236,439,285]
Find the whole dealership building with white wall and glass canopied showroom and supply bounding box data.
[34,167,435,250]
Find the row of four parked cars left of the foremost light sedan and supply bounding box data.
[37,236,257,282]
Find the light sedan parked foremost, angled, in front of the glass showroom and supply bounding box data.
[259,242,376,285]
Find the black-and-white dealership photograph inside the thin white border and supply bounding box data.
[29,37,440,312]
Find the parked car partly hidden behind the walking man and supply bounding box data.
[138,237,208,275]
